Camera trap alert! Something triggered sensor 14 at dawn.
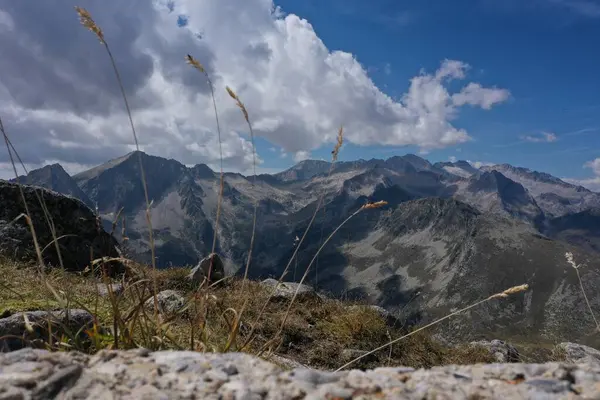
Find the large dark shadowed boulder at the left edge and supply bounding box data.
[0,181,120,271]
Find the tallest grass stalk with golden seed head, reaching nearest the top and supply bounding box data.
[75,6,160,333]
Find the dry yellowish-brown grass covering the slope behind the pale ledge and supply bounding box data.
[0,261,492,369]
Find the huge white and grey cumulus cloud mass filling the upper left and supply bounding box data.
[0,0,509,178]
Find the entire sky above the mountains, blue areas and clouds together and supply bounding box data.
[0,0,600,190]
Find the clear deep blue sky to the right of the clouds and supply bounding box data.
[258,0,600,178]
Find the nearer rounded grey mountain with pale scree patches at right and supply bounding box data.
[318,198,600,346]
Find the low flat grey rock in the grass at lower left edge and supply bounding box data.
[0,309,94,352]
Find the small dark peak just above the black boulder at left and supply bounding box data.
[10,164,95,210]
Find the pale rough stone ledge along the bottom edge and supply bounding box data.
[0,349,600,400]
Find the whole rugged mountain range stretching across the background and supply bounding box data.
[8,152,600,344]
